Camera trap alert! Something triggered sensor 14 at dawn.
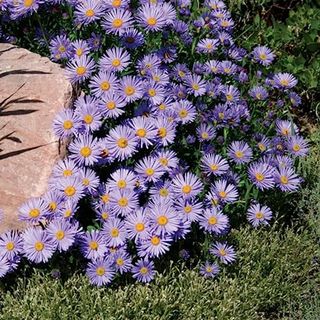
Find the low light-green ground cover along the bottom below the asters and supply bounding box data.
[0,222,320,320]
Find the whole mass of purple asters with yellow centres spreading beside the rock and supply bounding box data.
[0,0,308,286]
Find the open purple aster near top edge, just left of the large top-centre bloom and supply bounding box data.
[102,8,133,35]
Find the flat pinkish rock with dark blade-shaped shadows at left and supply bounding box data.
[0,44,72,233]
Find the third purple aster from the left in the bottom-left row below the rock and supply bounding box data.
[46,219,80,252]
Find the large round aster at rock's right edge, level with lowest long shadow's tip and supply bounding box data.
[68,135,100,166]
